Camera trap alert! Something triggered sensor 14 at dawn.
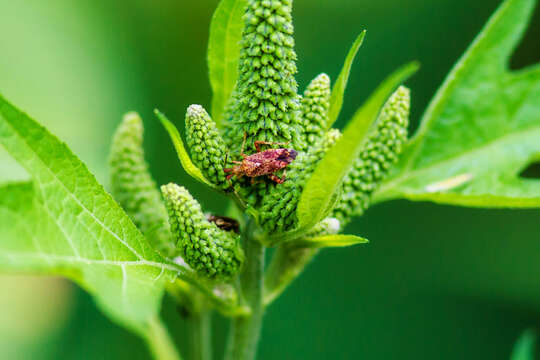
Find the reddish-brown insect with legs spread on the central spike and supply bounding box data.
[223,134,298,184]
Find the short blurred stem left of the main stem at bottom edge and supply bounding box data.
[190,311,212,360]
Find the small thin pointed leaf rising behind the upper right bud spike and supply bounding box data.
[327,30,366,128]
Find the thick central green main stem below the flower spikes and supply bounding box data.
[225,226,265,360]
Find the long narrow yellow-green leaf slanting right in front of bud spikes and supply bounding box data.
[296,63,418,229]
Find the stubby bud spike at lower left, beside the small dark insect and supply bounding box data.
[161,183,244,280]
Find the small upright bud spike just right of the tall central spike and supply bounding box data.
[302,74,330,147]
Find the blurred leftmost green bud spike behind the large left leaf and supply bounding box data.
[109,113,175,256]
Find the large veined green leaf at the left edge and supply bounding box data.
[0,97,189,334]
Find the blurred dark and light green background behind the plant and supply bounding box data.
[0,0,540,360]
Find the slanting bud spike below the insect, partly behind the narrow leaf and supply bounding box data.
[260,129,341,233]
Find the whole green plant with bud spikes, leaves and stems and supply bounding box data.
[0,0,540,359]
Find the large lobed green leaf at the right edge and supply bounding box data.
[375,0,540,207]
